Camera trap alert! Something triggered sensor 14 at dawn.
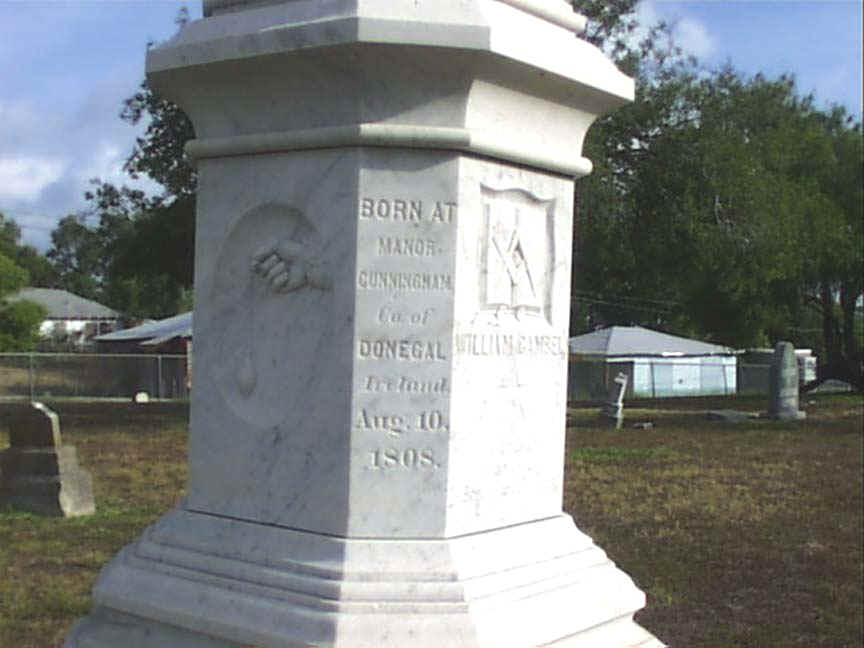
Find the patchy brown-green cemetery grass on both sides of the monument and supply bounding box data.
[0,395,864,648]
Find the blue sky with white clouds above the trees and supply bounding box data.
[0,0,862,249]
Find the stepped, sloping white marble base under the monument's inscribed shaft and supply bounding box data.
[64,509,663,648]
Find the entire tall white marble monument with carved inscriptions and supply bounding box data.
[66,0,661,648]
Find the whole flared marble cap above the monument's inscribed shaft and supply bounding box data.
[148,0,634,175]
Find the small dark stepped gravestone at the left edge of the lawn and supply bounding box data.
[0,403,96,517]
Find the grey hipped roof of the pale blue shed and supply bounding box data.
[570,326,734,356]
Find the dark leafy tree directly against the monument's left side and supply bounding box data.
[49,10,197,317]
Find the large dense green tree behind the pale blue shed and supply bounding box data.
[573,52,864,384]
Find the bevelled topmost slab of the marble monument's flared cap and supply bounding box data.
[147,0,634,107]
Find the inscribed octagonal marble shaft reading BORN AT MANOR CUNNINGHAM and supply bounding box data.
[187,149,572,537]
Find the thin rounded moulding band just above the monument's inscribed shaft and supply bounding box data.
[186,124,592,178]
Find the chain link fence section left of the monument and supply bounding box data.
[0,353,190,400]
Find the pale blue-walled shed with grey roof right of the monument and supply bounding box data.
[569,326,737,400]
